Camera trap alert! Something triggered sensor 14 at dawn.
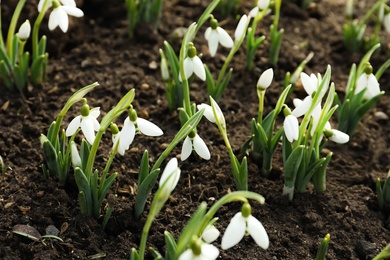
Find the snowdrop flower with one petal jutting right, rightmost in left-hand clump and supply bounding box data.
[114,106,163,155]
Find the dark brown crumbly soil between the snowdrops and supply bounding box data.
[0,0,390,259]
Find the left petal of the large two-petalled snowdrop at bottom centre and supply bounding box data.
[221,212,246,250]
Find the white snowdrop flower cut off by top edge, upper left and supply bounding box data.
[38,0,84,33]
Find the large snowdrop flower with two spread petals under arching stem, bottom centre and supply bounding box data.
[221,202,269,250]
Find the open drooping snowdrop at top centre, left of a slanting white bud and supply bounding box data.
[204,16,234,57]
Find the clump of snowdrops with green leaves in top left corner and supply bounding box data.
[0,0,84,91]
